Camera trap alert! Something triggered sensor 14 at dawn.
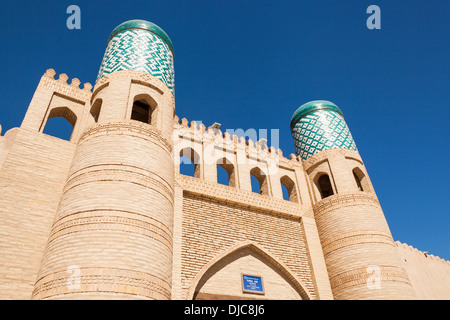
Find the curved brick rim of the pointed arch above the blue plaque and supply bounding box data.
[186,241,312,300]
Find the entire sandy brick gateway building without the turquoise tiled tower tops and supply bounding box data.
[0,69,450,300]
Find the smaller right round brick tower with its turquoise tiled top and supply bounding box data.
[291,101,414,300]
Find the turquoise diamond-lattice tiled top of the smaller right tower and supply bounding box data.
[291,100,357,160]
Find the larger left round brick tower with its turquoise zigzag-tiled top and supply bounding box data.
[33,20,175,299]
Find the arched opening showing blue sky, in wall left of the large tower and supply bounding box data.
[42,107,77,141]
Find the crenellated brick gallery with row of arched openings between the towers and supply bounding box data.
[172,116,310,207]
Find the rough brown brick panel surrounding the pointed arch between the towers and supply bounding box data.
[181,185,315,298]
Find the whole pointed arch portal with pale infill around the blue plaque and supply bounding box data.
[187,242,311,300]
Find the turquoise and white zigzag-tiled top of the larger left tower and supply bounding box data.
[97,20,175,93]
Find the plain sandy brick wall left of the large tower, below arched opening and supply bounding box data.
[0,129,75,299]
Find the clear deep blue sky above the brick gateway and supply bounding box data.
[0,0,450,260]
